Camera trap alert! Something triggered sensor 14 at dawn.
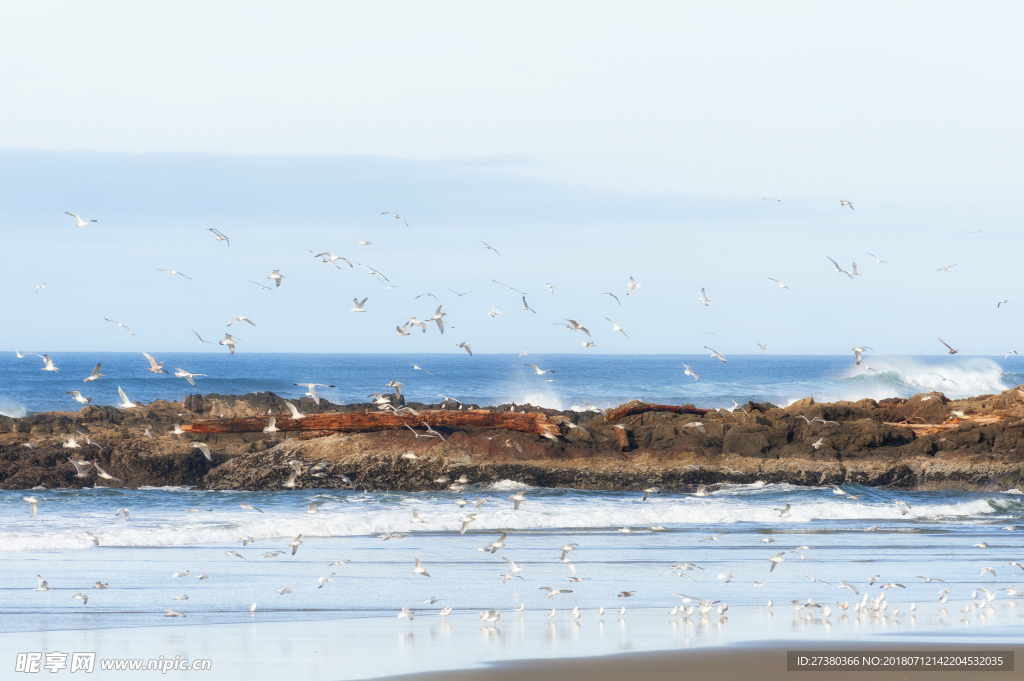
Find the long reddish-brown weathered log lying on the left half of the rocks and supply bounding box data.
[181,410,559,437]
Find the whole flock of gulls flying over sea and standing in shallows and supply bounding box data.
[6,204,1024,624]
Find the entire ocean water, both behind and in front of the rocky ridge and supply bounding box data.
[0,352,1024,681]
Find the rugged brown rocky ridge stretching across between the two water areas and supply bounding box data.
[0,386,1024,492]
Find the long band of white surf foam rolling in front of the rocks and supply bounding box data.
[0,491,997,551]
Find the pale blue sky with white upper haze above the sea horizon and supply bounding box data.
[0,2,1024,356]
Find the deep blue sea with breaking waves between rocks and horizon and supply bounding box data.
[0,350,1024,417]
